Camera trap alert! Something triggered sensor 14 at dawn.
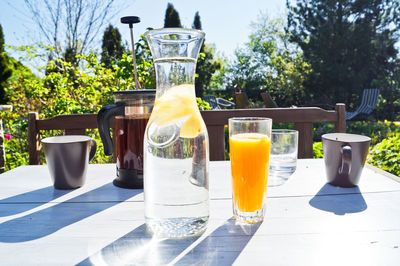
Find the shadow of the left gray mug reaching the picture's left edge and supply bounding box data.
[0,186,72,217]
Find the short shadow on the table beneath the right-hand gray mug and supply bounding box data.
[309,184,368,215]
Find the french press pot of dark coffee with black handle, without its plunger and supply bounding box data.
[97,90,156,188]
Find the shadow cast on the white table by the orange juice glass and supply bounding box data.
[176,217,261,265]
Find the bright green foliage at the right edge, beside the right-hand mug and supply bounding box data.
[368,133,400,176]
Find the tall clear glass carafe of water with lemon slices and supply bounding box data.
[144,28,209,238]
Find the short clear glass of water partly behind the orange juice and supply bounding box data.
[268,129,299,187]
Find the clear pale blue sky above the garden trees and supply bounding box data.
[0,0,286,60]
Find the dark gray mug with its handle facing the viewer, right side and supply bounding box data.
[322,133,371,187]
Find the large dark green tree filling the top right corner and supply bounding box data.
[287,0,399,113]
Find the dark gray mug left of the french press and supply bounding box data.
[42,135,97,189]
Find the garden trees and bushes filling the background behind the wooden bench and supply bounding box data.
[0,0,400,176]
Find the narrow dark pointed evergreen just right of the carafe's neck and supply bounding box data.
[192,12,222,97]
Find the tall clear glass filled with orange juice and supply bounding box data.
[229,117,272,223]
